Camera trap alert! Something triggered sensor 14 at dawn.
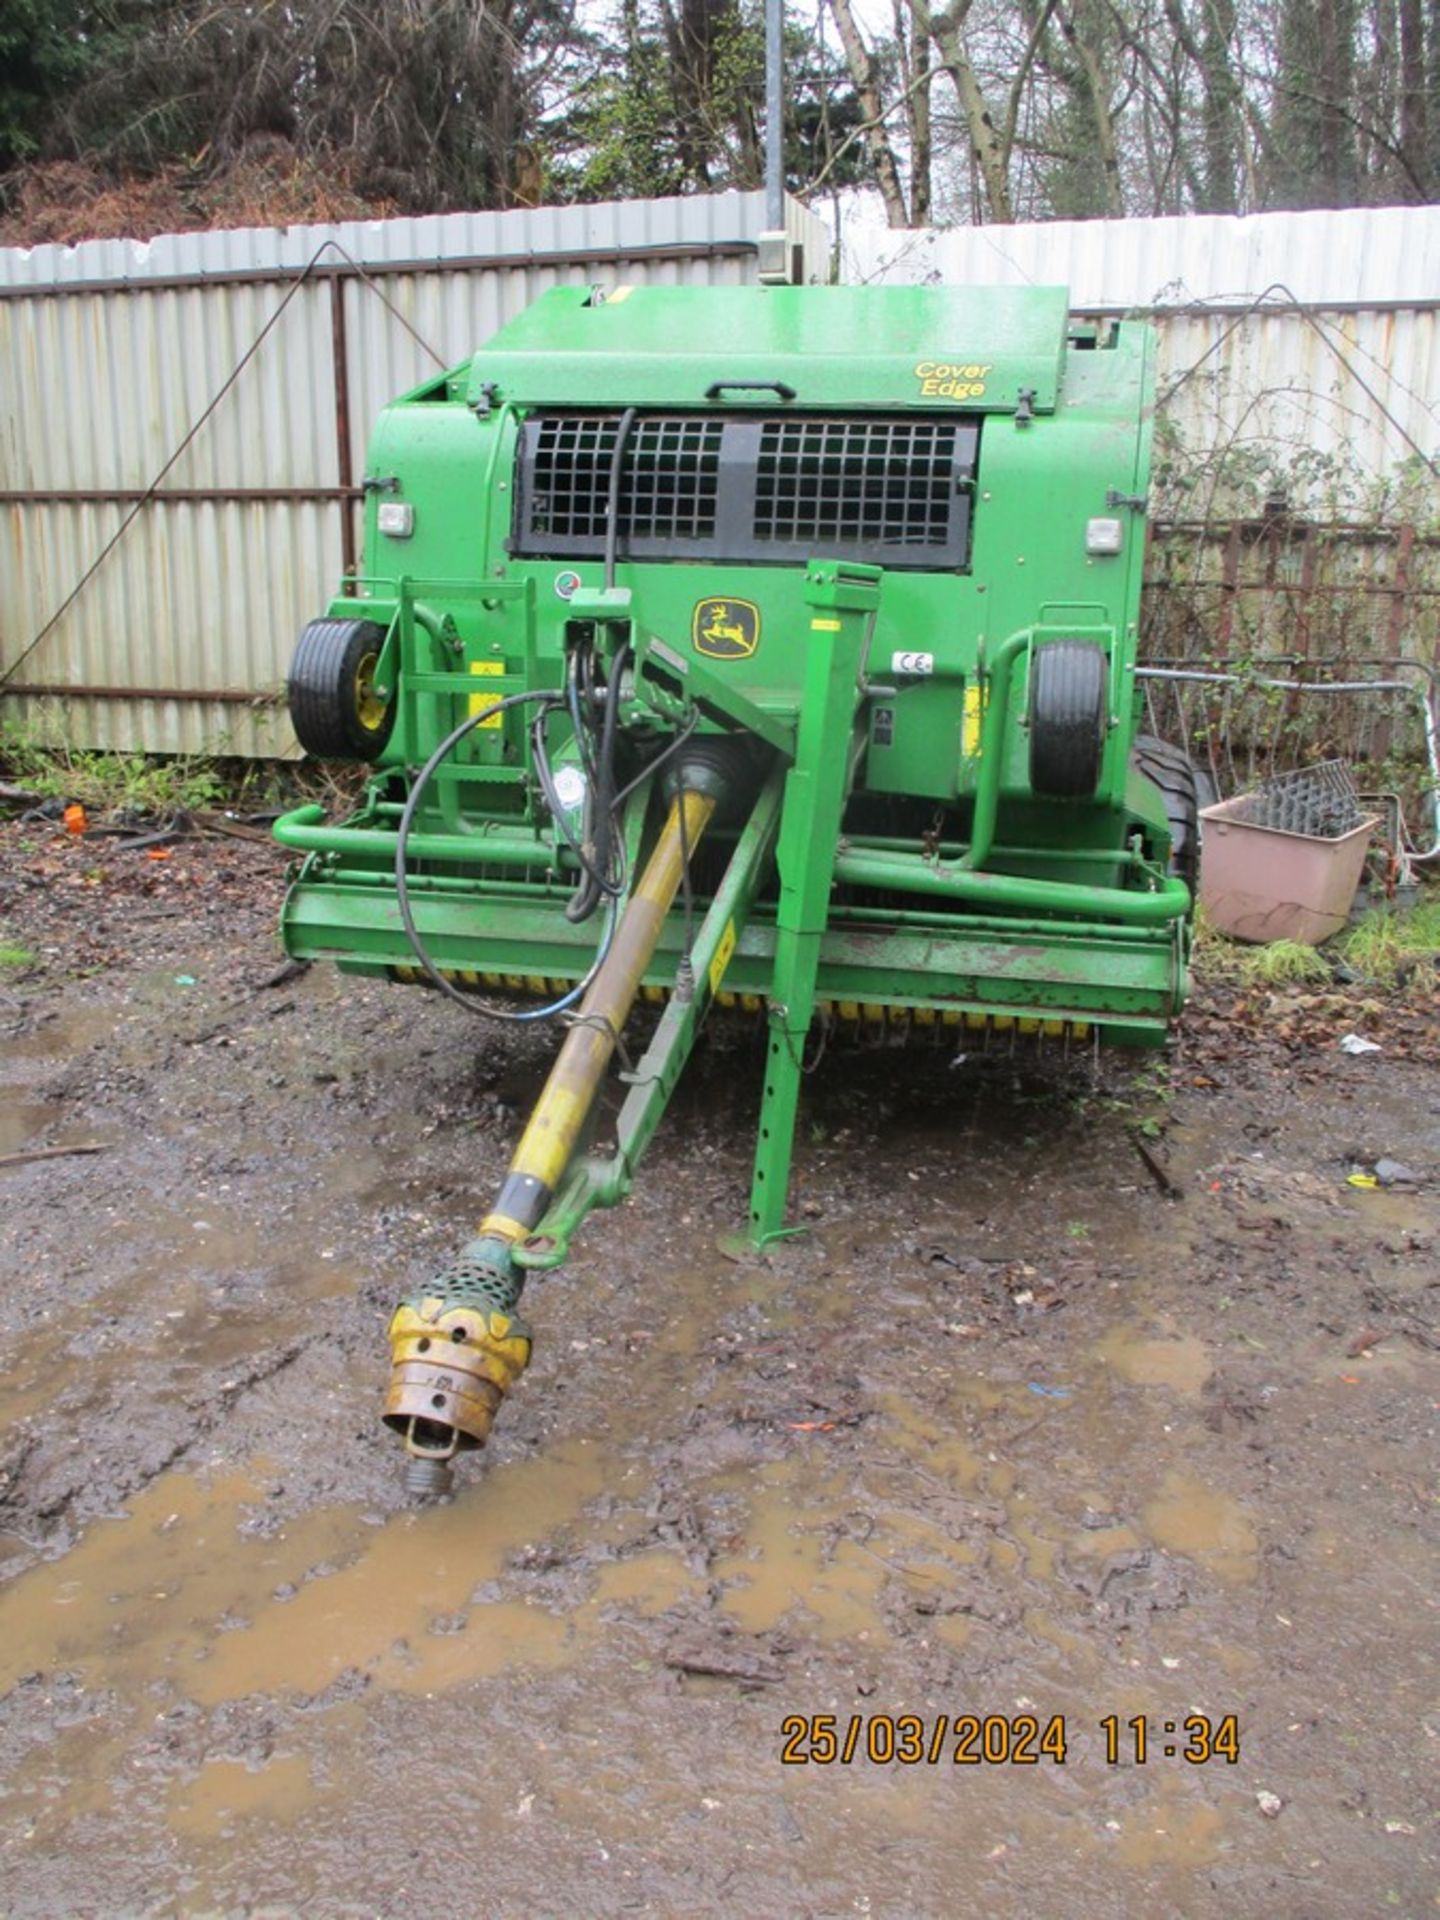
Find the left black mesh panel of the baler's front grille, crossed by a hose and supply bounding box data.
[524,415,724,543]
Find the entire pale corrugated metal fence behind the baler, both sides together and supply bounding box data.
[0,194,1440,755]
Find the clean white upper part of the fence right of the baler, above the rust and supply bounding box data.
[843,207,1440,511]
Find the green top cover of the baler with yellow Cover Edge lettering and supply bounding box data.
[467,286,1068,413]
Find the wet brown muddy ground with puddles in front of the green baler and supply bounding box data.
[0,826,1440,1920]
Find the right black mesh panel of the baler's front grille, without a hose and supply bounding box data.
[755,420,956,547]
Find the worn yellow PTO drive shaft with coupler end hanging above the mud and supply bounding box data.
[384,743,726,1498]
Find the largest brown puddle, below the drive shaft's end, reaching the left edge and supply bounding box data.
[0,1442,624,1705]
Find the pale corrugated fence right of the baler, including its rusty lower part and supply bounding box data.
[843,207,1440,721]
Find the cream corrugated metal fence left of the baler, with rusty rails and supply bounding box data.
[0,194,829,756]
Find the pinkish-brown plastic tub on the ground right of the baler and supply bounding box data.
[1200,795,1379,947]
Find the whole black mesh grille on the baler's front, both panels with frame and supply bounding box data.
[511,409,979,568]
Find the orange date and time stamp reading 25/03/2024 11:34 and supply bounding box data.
[780,1713,1240,1766]
